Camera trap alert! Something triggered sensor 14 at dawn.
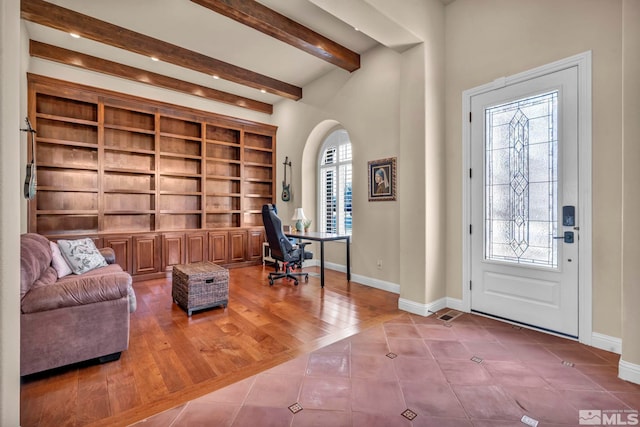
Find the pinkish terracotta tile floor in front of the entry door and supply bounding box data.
[134,310,640,427]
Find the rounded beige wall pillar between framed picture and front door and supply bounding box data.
[398,1,446,306]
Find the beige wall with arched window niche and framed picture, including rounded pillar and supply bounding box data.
[274,0,445,305]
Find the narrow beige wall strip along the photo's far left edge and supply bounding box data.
[0,0,26,426]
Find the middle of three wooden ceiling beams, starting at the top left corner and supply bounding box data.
[21,0,302,100]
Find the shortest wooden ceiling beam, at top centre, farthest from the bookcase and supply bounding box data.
[191,0,360,72]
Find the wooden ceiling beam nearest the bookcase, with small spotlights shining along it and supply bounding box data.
[29,40,273,114]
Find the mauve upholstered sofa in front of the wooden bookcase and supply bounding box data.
[20,233,135,375]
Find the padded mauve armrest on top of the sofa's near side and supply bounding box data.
[22,265,131,313]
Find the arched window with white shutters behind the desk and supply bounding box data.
[318,129,352,235]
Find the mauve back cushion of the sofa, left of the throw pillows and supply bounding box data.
[20,233,51,298]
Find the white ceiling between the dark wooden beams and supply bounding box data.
[25,0,444,108]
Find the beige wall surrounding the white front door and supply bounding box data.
[445,0,622,338]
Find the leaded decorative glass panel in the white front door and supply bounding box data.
[484,91,558,268]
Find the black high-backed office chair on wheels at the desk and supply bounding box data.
[262,204,313,286]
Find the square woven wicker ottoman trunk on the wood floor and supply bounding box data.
[171,261,229,316]
